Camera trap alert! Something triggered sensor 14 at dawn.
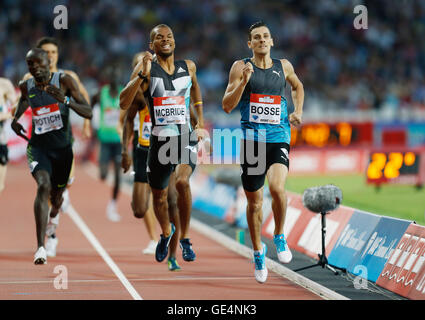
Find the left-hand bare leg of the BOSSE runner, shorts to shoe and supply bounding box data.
[245,188,263,251]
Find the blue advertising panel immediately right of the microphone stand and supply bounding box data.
[328,210,381,269]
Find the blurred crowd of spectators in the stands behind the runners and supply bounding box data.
[0,0,425,122]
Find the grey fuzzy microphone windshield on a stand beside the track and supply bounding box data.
[303,184,342,213]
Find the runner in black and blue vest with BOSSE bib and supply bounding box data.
[223,22,304,283]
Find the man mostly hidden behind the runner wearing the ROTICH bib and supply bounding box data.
[23,37,91,257]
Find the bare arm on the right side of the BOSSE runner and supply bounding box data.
[281,59,304,126]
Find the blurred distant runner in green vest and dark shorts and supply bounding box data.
[92,67,122,222]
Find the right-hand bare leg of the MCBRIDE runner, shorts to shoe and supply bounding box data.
[175,164,192,239]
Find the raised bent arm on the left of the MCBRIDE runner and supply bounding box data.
[120,52,153,110]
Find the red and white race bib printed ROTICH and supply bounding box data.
[32,103,63,134]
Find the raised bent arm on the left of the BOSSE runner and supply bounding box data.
[222,60,254,113]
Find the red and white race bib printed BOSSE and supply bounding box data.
[249,93,281,124]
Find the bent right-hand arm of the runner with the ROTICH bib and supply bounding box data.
[45,74,93,119]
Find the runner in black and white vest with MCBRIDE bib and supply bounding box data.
[120,24,204,262]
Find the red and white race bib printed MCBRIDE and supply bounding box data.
[153,96,186,126]
